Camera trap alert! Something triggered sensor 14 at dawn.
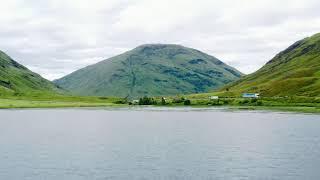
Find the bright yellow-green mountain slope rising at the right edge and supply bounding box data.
[223,33,320,96]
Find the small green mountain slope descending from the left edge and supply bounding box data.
[0,51,58,95]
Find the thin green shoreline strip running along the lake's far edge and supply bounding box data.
[0,99,320,114]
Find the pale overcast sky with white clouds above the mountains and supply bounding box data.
[0,0,320,80]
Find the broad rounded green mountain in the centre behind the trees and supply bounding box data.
[54,44,242,97]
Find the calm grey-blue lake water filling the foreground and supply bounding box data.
[0,108,320,180]
